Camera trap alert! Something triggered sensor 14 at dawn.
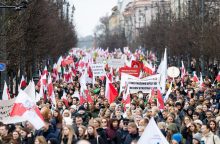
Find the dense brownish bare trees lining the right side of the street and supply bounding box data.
[138,0,220,71]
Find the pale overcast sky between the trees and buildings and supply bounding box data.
[69,0,117,37]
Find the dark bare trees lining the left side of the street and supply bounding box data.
[0,0,77,94]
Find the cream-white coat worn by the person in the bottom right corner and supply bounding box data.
[202,132,220,144]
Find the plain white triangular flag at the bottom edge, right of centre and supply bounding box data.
[137,117,169,144]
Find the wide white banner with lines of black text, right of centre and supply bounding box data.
[127,75,159,93]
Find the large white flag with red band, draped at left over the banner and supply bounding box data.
[10,90,44,130]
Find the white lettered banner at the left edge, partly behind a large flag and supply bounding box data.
[0,98,25,124]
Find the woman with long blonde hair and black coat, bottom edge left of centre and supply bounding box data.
[61,125,77,144]
